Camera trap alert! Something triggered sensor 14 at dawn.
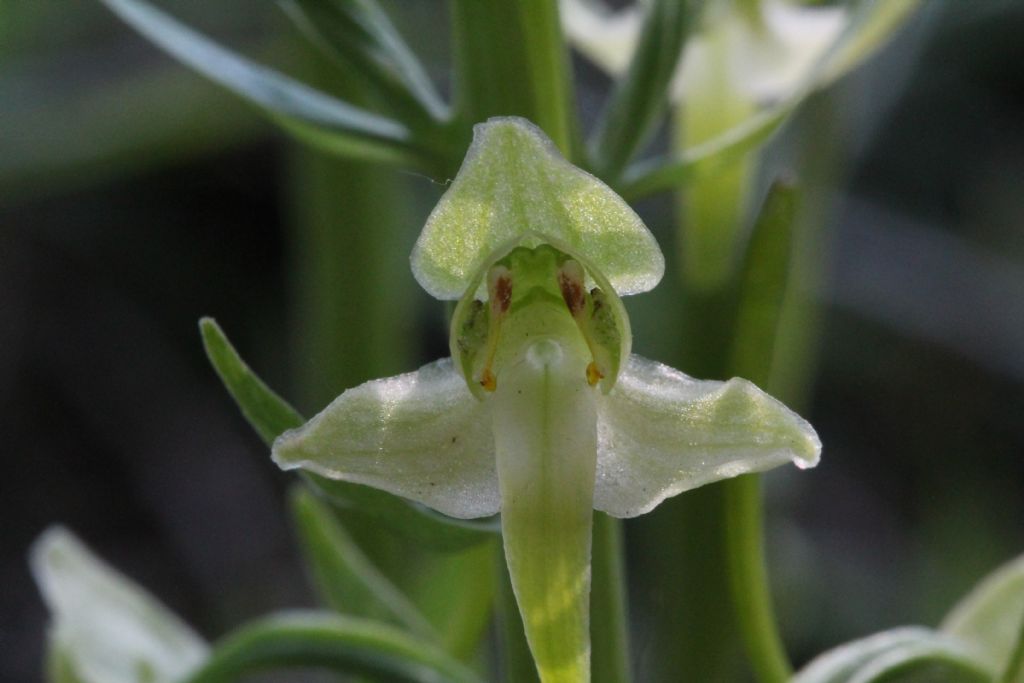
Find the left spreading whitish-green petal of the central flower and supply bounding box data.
[272,358,499,519]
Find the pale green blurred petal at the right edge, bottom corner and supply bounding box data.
[941,555,1024,683]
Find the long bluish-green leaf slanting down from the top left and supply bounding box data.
[101,0,420,164]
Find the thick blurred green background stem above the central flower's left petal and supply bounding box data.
[288,147,415,405]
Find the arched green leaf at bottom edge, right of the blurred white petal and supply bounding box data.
[182,612,480,683]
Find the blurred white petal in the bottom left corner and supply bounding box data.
[31,527,208,683]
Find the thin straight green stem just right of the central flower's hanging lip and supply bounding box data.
[593,512,632,683]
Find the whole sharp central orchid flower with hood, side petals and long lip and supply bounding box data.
[272,118,820,682]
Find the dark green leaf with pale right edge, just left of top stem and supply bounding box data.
[282,0,447,125]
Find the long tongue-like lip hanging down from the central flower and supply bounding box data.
[490,340,597,683]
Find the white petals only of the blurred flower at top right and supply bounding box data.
[560,0,920,112]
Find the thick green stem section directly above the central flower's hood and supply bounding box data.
[451,0,575,156]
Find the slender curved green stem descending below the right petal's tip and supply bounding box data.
[723,474,793,683]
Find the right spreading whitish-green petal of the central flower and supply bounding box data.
[594,355,821,517]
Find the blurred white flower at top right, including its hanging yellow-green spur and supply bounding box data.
[560,0,921,291]
